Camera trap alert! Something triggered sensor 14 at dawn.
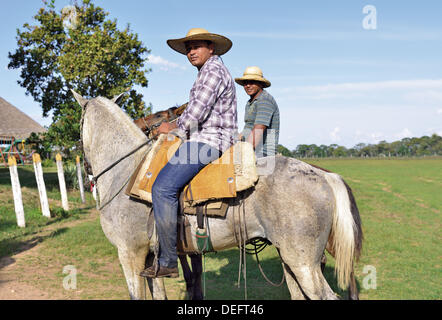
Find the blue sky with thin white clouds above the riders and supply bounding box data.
[0,0,442,149]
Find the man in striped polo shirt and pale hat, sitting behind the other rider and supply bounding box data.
[235,67,279,158]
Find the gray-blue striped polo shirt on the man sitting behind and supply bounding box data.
[242,90,279,158]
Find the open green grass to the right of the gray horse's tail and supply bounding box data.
[309,158,442,299]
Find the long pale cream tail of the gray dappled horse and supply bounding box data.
[324,172,363,290]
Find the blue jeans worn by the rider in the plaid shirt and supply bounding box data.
[152,141,221,268]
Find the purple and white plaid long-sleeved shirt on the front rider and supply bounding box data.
[177,56,238,152]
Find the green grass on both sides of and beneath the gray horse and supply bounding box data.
[0,158,442,300]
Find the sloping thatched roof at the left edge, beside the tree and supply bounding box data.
[0,97,46,139]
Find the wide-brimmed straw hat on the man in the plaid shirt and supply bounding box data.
[167,28,232,56]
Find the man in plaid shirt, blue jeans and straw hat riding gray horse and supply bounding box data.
[141,28,238,278]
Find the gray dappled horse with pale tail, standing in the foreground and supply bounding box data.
[74,93,362,299]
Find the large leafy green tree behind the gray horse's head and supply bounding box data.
[8,0,150,158]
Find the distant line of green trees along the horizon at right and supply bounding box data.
[278,134,442,158]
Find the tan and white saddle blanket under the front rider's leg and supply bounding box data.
[126,134,258,207]
